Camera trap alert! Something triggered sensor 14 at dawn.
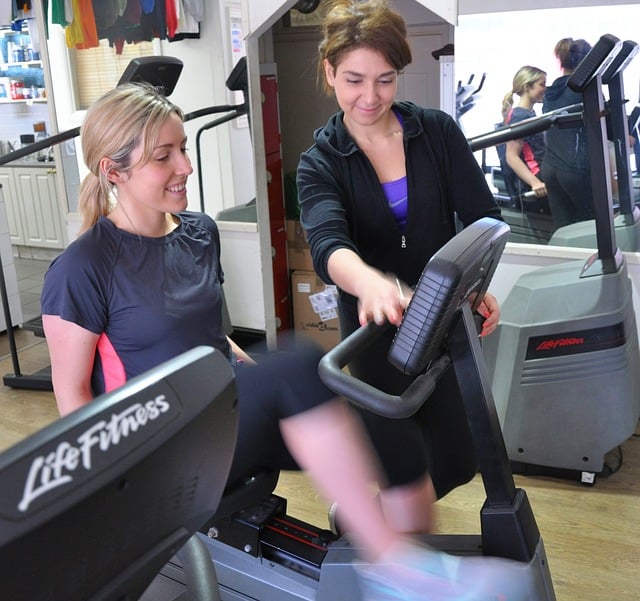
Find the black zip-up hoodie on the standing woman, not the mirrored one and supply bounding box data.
[297,101,500,324]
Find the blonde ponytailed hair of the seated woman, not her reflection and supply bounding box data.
[78,83,184,233]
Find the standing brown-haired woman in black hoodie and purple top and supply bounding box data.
[297,0,516,584]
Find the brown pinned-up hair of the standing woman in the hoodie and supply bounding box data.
[318,0,412,94]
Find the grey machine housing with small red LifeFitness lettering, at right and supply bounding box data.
[483,261,640,472]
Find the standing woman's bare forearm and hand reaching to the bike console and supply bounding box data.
[327,248,412,325]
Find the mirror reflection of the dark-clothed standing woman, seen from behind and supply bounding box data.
[542,38,594,228]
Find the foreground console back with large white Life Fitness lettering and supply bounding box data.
[0,347,237,601]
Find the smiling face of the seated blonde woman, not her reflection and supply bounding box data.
[111,114,193,216]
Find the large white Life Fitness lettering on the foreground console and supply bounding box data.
[18,394,171,512]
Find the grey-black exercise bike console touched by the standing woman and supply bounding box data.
[388,217,509,375]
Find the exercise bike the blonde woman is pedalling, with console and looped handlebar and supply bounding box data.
[142,218,555,601]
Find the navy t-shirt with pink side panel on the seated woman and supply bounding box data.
[41,212,230,395]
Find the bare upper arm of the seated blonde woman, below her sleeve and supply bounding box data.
[42,315,99,415]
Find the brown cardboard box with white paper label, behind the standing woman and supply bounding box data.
[291,271,340,351]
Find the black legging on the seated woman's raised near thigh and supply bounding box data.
[228,336,336,483]
